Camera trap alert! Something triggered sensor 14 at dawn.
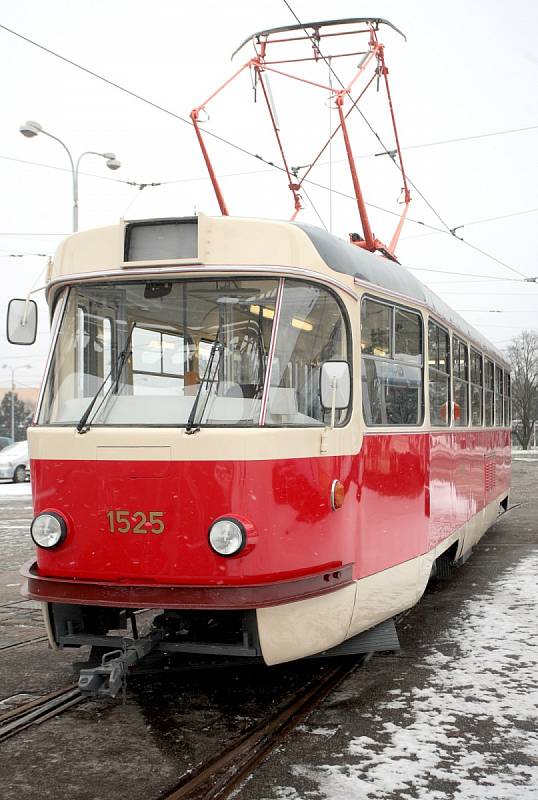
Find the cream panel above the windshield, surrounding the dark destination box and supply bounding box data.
[48,214,353,287]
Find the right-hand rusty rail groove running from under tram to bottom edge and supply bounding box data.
[161,656,360,800]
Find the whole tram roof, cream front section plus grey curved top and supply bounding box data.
[47,213,508,364]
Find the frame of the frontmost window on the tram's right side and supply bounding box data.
[358,293,426,430]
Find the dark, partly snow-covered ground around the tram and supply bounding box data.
[0,461,538,800]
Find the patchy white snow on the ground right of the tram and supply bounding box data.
[274,554,538,800]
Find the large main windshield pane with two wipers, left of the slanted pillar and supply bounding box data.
[39,278,278,426]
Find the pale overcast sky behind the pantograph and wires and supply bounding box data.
[0,0,538,386]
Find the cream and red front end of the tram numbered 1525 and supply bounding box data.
[9,212,359,663]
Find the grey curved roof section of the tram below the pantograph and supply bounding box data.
[294,223,508,363]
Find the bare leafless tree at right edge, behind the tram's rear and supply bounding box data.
[508,331,538,450]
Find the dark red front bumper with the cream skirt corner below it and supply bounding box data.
[21,561,355,665]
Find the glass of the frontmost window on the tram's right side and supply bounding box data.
[361,299,424,425]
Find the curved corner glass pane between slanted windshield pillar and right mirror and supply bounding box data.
[266,280,350,426]
